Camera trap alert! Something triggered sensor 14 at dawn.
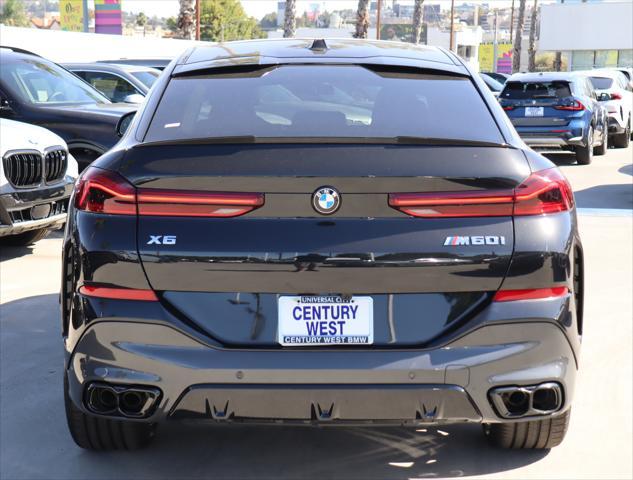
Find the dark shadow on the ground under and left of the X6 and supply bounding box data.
[0,294,547,480]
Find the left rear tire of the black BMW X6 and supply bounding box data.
[64,374,156,451]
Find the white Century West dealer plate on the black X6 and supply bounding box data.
[277,295,374,346]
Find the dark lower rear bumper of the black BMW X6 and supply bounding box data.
[67,312,577,425]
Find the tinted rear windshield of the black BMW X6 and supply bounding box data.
[146,65,503,143]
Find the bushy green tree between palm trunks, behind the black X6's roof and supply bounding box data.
[200,0,266,42]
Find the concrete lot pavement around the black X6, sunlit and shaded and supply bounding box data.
[0,144,633,480]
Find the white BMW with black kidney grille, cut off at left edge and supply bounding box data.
[0,119,78,245]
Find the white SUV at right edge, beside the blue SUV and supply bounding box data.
[587,69,633,148]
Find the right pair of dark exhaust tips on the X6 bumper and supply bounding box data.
[490,382,563,418]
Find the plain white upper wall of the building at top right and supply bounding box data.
[539,0,633,51]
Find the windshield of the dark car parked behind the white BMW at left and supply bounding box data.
[0,57,110,105]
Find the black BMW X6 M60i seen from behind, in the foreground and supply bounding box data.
[61,39,583,449]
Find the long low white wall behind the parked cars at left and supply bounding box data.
[0,25,210,63]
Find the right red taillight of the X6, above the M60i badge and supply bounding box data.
[389,168,574,218]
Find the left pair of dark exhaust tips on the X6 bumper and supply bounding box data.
[84,383,161,418]
